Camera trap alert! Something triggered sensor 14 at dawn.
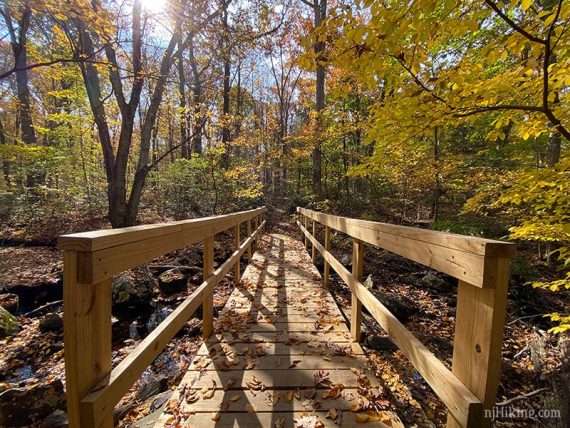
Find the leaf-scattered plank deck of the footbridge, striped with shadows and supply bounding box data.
[157,234,400,428]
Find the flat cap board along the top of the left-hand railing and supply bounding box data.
[58,207,267,252]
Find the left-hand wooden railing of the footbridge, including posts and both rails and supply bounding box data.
[58,207,266,428]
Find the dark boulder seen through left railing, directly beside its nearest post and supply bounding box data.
[113,268,157,307]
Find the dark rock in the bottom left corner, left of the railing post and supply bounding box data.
[0,379,65,426]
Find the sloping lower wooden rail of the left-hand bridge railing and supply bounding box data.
[80,224,264,427]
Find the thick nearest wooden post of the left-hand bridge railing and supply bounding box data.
[63,250,113,428]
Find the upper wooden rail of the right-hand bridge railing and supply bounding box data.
[300,208,516,287]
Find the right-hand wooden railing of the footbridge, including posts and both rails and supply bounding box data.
[297,207,516,427]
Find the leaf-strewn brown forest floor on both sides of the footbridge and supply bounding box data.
[0,206,570,427]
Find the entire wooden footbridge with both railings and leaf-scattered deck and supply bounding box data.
[59,208,516,428]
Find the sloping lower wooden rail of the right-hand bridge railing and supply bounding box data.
[297,222,482,426]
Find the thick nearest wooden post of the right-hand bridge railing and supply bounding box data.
[447,258,510,428]
